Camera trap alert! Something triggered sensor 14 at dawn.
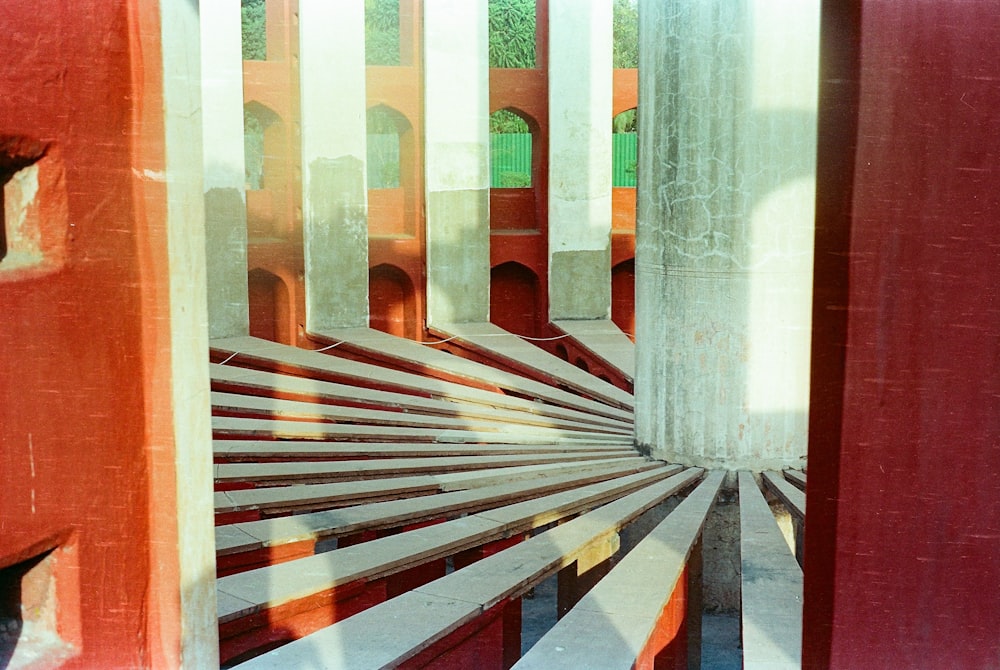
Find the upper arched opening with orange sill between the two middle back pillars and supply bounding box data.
[366,105,417,235]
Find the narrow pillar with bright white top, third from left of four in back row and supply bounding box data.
[424,0,490,324]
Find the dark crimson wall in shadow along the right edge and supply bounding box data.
[804,0,1000,669]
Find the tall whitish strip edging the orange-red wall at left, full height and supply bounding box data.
[161,0,219,669]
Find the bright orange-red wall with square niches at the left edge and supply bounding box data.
[0,0,189,668]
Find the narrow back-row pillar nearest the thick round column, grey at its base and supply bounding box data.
[549,0,612,320]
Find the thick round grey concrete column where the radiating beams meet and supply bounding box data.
[635,0,819,470]
